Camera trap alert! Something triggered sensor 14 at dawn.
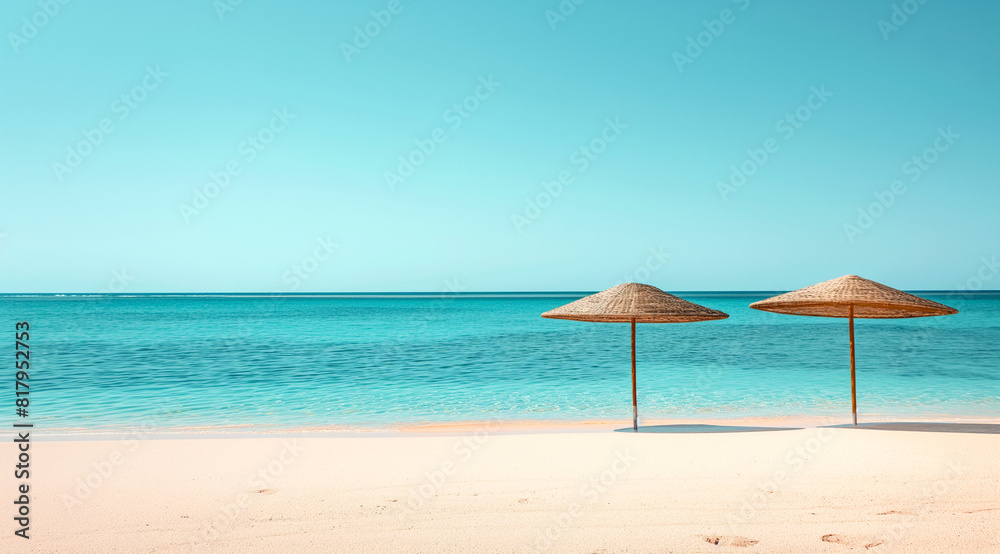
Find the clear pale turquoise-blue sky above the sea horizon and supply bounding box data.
[0,0,1000,293]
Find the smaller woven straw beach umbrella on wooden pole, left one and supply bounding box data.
[542,283,729,431]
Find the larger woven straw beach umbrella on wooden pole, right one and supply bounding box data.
[750,275,958,425]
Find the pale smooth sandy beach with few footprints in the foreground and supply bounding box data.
[0,423,1000,552]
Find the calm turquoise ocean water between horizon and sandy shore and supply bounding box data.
[0,293,1000,432]
